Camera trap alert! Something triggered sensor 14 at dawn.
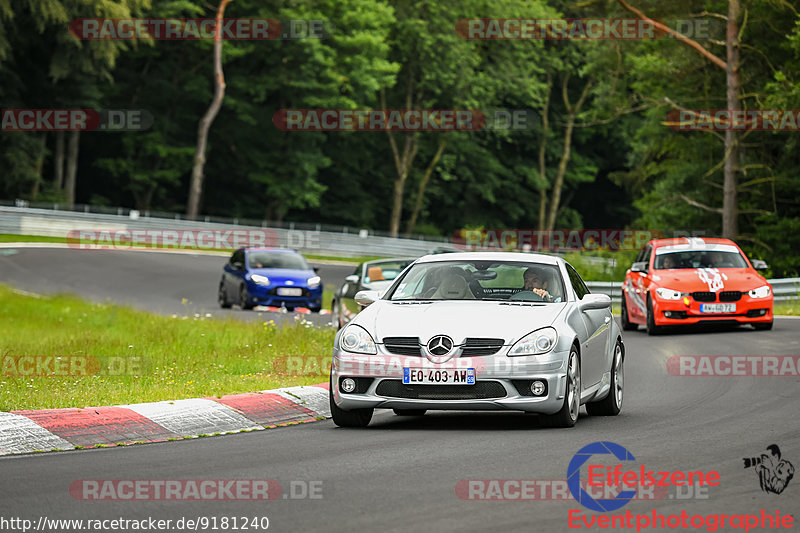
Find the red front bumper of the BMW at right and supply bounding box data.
[653,295,773,326]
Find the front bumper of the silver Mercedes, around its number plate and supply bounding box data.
[331,345,569,414]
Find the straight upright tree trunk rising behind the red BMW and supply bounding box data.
[722,0,739,239]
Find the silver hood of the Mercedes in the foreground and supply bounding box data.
[354,300,567,344]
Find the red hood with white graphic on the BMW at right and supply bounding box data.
[652,268,766,292]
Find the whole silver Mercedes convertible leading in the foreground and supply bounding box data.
[330,252,625,427]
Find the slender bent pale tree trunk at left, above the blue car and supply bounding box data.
[186,0,231,219]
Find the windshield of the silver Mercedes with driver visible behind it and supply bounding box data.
[388,261,564,303]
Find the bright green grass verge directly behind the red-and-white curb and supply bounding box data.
[0,286,335,411]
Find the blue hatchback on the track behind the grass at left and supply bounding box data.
[218,248,322,312]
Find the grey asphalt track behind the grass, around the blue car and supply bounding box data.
[0,248,354,324]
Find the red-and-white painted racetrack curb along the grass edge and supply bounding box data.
[0,383,331,455]
